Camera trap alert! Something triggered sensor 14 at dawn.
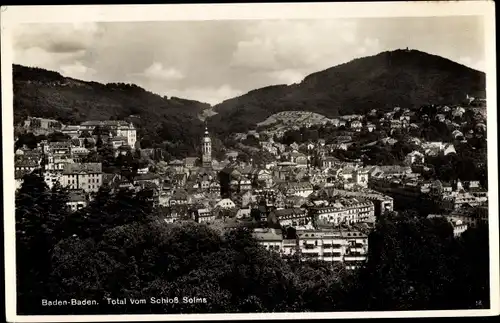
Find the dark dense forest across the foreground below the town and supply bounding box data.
[15,173,489,315]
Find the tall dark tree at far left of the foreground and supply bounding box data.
[15,173,68,312]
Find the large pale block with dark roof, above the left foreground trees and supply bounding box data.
[61,163,103,192]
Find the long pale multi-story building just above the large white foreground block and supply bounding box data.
[310,197,375,225]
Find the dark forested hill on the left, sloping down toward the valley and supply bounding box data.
[13,65,210,153]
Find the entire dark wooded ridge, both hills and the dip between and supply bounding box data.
[13,49,486,146]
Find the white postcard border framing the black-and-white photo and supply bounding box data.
[1,1,500,322]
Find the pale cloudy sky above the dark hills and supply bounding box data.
[13,16,485,104]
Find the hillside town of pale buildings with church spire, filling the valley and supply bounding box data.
[15,97,488,269]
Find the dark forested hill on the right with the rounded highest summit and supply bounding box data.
[209,50,486,133]
